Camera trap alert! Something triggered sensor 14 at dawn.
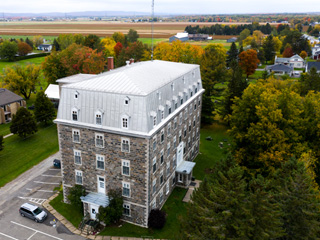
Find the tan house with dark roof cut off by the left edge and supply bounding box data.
[0,88,26,124]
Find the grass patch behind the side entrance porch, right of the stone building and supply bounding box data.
[193,123,231,180]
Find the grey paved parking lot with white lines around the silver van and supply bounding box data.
[0,164,85,240]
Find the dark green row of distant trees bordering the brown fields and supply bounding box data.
[185,23,272,35]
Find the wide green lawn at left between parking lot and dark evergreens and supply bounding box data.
[0,124,59,187]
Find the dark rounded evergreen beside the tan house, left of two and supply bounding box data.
[10,107,38,138]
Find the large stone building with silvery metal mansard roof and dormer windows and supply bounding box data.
[55,61,204,227]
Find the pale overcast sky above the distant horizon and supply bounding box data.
[0,0,320,14]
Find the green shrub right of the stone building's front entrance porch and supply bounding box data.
[98,189,123,225]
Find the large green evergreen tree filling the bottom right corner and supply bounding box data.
[275,158,320,240]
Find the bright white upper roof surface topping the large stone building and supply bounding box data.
[63,60,198,96]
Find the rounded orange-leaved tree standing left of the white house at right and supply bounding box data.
[239,49,260,77]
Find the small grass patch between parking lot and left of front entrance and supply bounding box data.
[50,193,83,228]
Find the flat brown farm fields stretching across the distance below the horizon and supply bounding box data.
[0,22,255,39]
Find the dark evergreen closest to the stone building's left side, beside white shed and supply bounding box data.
[34,91,56,125]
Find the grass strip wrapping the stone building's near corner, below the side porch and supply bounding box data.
[100,187,187,239]
